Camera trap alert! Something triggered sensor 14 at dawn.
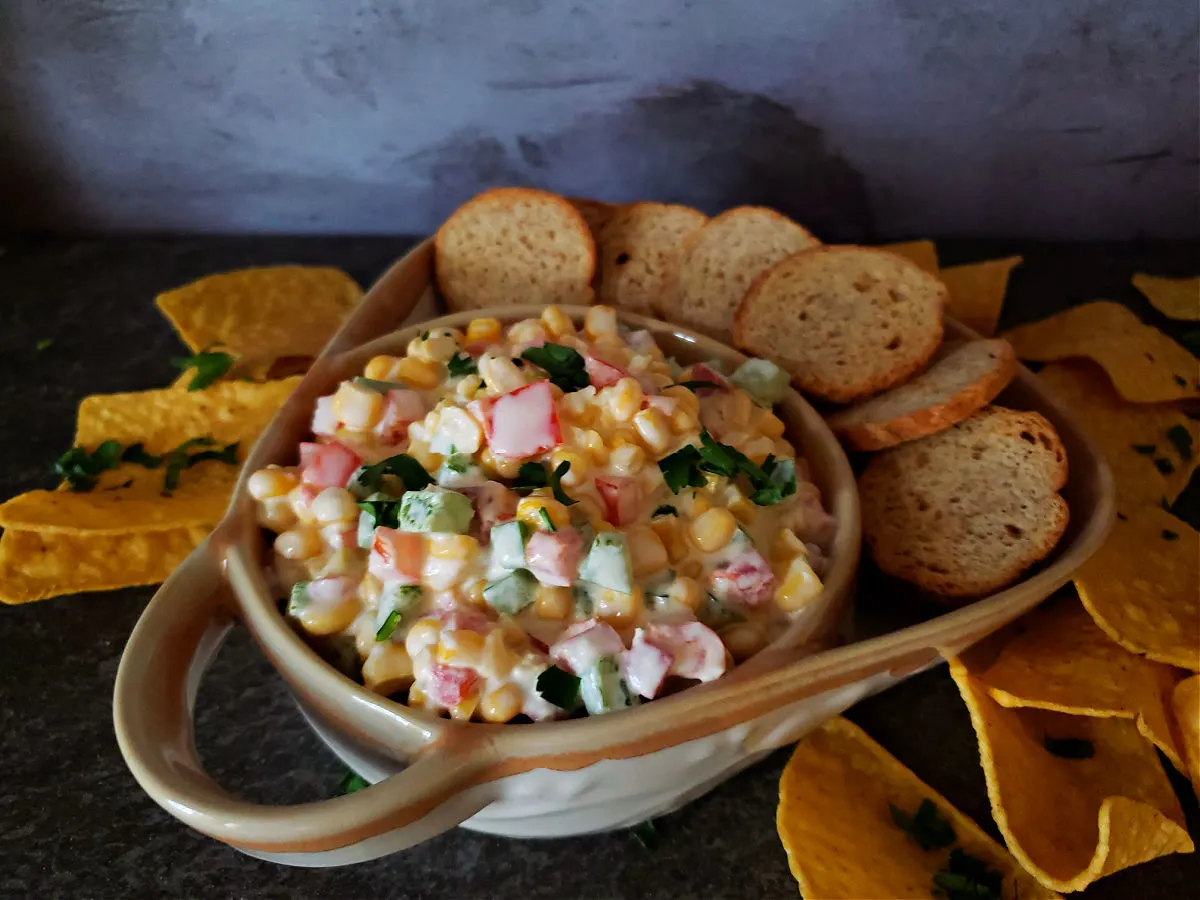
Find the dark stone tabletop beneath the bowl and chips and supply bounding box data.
[0,239,1200,900]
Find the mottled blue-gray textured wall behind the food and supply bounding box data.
[0,0,1200,239]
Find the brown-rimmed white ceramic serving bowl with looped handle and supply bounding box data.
[114,242,1114,866]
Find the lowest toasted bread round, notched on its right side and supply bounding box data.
[858,407,1069,598]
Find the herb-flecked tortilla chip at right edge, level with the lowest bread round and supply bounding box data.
[1038,360,1200,506]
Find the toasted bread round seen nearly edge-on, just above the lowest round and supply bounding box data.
[828,338,1016,450]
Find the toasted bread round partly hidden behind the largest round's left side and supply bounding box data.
[658,206,821,342]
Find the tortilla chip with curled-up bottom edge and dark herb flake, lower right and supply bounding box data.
[950,660,1194,890]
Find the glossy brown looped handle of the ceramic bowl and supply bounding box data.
[113,541,494,865]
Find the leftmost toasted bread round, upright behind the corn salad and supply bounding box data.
[433,187,595,310]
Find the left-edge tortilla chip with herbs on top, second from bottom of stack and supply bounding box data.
[0,462,238,534]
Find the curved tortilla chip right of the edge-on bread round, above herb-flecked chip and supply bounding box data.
[1004,300,1200,403]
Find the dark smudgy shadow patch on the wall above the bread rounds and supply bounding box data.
[384,82,875,240]
